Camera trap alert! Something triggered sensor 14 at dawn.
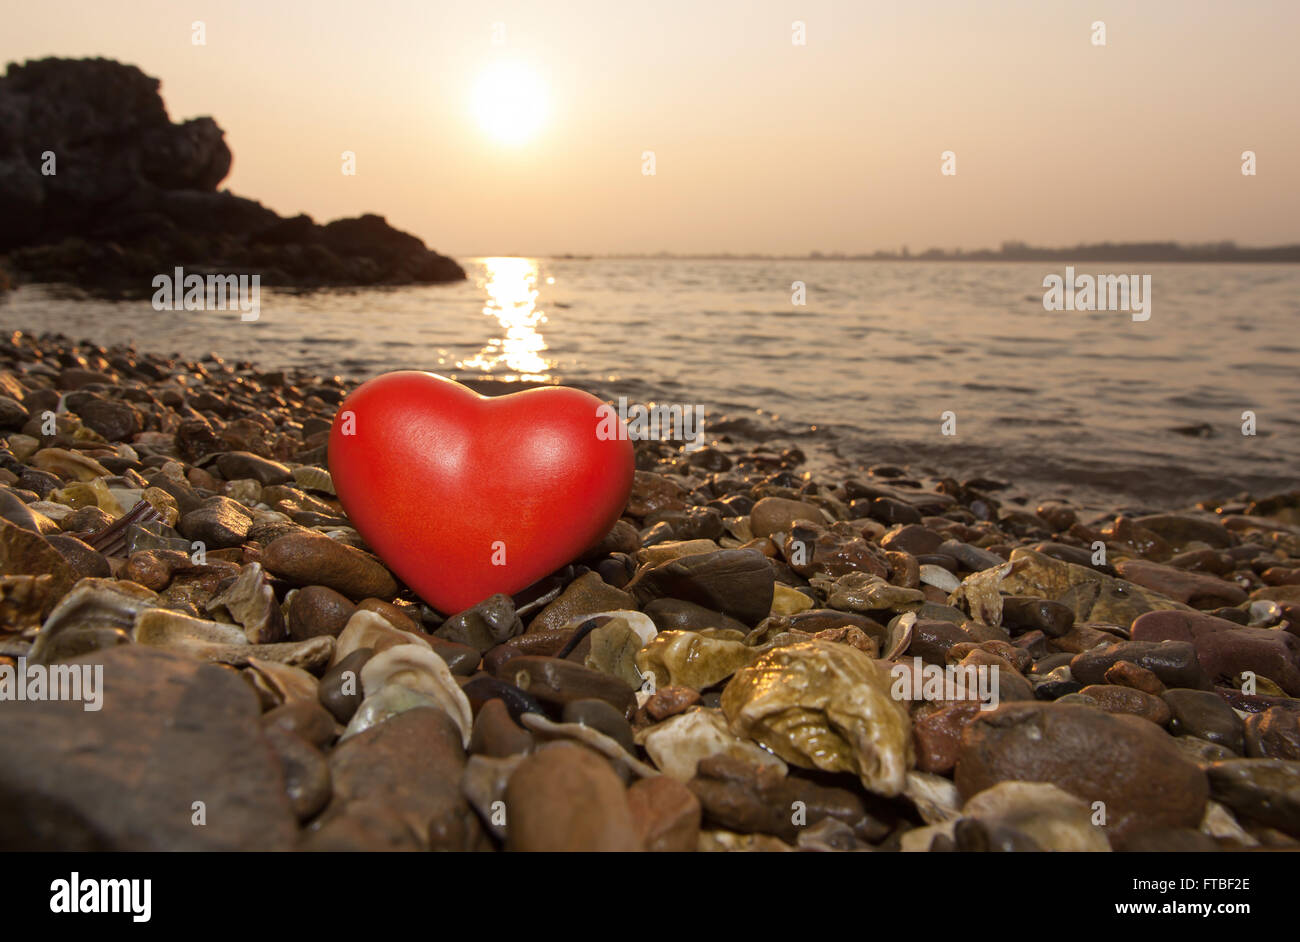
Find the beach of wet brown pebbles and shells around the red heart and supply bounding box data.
[0,331,1300,852]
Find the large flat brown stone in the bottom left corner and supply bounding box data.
[0,644,298,851]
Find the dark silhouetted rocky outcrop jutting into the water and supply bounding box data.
[0,58,465,294]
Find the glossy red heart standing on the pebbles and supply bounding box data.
[329,370,634,615]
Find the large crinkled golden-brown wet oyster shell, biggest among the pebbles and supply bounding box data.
[722,641,913,796]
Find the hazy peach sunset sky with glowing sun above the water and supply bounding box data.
[0,0,1300,255]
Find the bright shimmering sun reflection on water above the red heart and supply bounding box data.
[456,259,553,381]
